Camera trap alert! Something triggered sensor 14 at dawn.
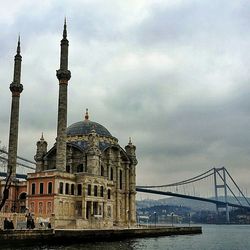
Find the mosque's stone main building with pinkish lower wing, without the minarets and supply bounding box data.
[28,114,137,228]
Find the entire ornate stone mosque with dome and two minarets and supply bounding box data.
[1,20,137,228]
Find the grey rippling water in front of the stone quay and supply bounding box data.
[1,225,250,250]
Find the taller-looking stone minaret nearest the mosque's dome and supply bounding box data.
[56,18,71,171]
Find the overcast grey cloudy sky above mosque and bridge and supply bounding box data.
[0,0,250,196]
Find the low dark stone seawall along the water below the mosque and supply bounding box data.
[0,226,202,246]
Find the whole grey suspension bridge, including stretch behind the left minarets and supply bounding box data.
[0,149,250,223]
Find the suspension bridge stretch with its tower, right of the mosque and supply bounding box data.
[136,167,250,223]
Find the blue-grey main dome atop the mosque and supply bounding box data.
[67,119,113,137]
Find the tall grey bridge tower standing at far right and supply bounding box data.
[214,167,230,223]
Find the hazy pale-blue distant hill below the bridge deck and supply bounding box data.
[136,196,250,211]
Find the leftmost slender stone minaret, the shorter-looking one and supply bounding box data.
[7,36,23,180]
